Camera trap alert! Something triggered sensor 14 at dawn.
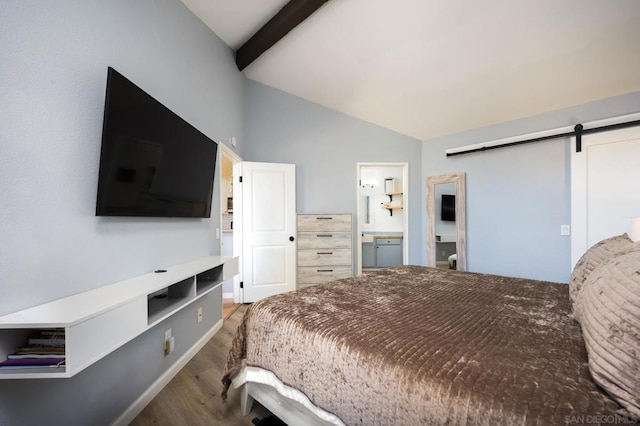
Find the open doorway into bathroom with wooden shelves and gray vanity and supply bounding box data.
[356,163,409,275]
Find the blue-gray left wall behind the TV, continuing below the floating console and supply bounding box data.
[0,0,245,426]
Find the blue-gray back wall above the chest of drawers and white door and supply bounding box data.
[244,80,426,264]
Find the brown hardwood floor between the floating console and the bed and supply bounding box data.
[131,305,269,426]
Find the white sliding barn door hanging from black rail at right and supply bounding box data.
[571,127,640,270]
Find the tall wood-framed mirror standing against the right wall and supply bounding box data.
[427,173,467,271]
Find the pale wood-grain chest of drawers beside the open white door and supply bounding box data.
[298,213,353,289]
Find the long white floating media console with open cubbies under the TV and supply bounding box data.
[0,256,238,379]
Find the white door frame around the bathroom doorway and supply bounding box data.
[356,162,409,275]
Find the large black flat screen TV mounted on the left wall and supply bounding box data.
[96,67,218,218]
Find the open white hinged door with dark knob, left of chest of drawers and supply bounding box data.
[234,161,296,303]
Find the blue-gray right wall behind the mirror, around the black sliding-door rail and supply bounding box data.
[422,92,640,282]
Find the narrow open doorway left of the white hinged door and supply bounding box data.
[220,144,242,312]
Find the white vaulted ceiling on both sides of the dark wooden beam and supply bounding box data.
[182,0,640,140]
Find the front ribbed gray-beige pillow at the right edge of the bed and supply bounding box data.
[580,251,640,418]
